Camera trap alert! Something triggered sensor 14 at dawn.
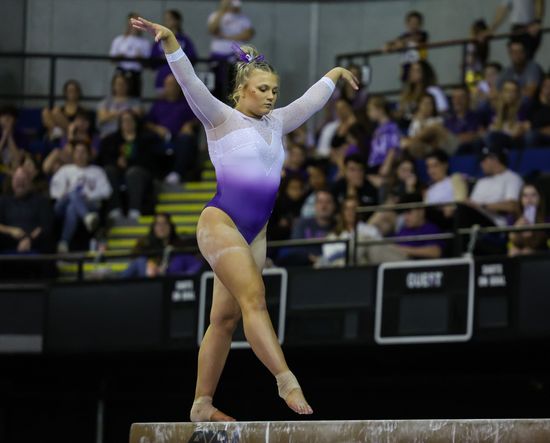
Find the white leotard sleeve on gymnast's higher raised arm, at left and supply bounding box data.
[166,48,232,129]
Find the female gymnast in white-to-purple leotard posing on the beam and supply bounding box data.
[132,14,358,422]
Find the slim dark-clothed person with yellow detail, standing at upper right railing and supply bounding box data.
[464,19,489,89]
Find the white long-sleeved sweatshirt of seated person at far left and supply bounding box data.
[50,164,113,200]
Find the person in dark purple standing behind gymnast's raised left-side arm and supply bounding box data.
[150,9,198,92]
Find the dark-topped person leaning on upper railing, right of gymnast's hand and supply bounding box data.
[382,11,429,82]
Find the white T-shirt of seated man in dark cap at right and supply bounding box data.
[470,169,523,225]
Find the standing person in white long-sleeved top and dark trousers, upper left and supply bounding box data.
[109,12,151,97]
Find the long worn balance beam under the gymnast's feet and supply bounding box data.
[130,419,550,443]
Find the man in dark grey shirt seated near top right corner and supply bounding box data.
[499,39,543,98]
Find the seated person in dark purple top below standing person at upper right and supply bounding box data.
[445,86,483,154]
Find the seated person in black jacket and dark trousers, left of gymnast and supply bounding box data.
[98,110,158,220]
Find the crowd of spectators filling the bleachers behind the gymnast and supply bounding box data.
[0,0,550,275]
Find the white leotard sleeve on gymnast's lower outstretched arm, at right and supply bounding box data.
[273,77,335,134]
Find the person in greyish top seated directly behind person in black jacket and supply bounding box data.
[97,72,143,138]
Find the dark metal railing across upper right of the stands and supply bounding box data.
[336,28,550,95]
